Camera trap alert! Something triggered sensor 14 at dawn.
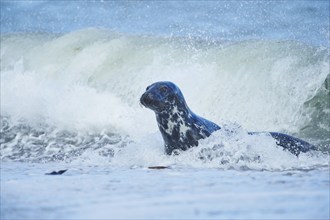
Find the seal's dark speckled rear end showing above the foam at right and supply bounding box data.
[269,132,317,156]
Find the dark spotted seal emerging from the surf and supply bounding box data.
[140,81,316,156]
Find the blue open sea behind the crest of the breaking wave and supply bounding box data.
[1,0,330,46]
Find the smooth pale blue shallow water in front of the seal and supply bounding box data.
[1,163,330,219]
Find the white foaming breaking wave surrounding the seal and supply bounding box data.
[1,29,330,170]
